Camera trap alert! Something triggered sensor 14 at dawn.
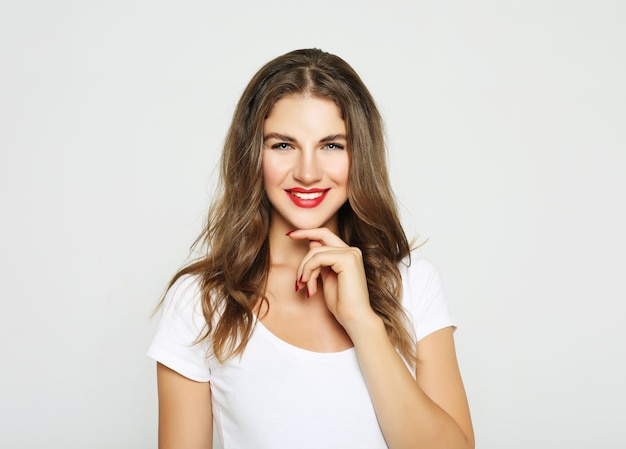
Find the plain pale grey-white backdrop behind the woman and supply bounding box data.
[0,0,626,449]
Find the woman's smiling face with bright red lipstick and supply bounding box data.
[263,94,350,232]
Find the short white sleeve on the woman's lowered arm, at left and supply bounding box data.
[148,275,211,382]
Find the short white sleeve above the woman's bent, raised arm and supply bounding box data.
[401,254,456,341]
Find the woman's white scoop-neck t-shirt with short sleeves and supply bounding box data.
[148,254,454,449]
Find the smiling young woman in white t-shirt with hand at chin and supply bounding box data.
[149,49,474,449]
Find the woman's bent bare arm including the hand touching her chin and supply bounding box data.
[289,229,474,449]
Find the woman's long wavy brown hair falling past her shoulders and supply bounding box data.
[169,49,416,363]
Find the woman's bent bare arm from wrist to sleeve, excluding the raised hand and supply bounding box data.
[348,317,474,449]
